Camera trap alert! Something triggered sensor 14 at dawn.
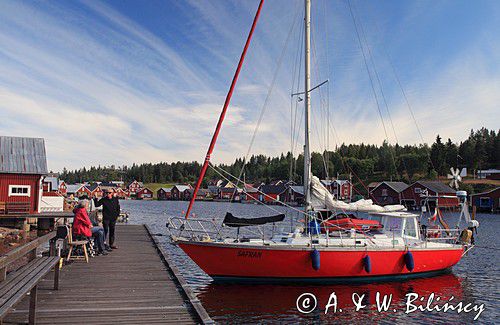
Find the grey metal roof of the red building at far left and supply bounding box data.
[0,136,47,175]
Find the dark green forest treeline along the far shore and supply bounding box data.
[60,128,500,192]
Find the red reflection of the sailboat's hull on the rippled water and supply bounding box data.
[198,274,470,322]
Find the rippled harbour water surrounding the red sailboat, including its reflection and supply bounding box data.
[121,201,500,324]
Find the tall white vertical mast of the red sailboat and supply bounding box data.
[304,0,311,211]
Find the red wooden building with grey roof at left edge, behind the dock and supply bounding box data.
[0,136,47,214]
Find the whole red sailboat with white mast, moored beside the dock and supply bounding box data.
[167,0,478,281]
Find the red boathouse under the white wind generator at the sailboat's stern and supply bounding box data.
[401,181,459,208]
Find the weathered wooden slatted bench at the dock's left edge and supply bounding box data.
[0,232,60,324]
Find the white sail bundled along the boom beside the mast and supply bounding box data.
[311,176,406,212]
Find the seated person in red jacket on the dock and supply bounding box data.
[73,200,107,255]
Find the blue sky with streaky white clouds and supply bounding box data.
[0,0,500,171]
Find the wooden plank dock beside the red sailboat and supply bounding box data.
[4,225,213,324]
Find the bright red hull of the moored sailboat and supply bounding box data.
[179,242,463,279]
